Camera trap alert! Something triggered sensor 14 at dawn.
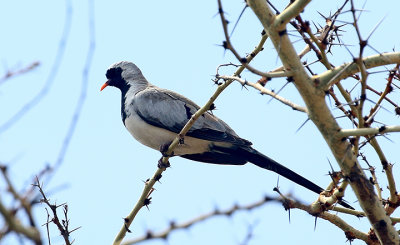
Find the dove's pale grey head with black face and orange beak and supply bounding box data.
[100,61,147,91]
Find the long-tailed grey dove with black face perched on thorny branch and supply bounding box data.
[100,61,351,208]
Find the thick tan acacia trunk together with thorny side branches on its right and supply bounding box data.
[245,1,400,244]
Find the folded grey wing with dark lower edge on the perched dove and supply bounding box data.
[133,87,251,146]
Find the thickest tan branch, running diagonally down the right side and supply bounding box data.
[248,0,400,241]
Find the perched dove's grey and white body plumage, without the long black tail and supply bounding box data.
[107,61,251,157]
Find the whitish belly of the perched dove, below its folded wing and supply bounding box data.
[125,114,209,156]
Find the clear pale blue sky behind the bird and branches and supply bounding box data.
[0,0,400,244]
